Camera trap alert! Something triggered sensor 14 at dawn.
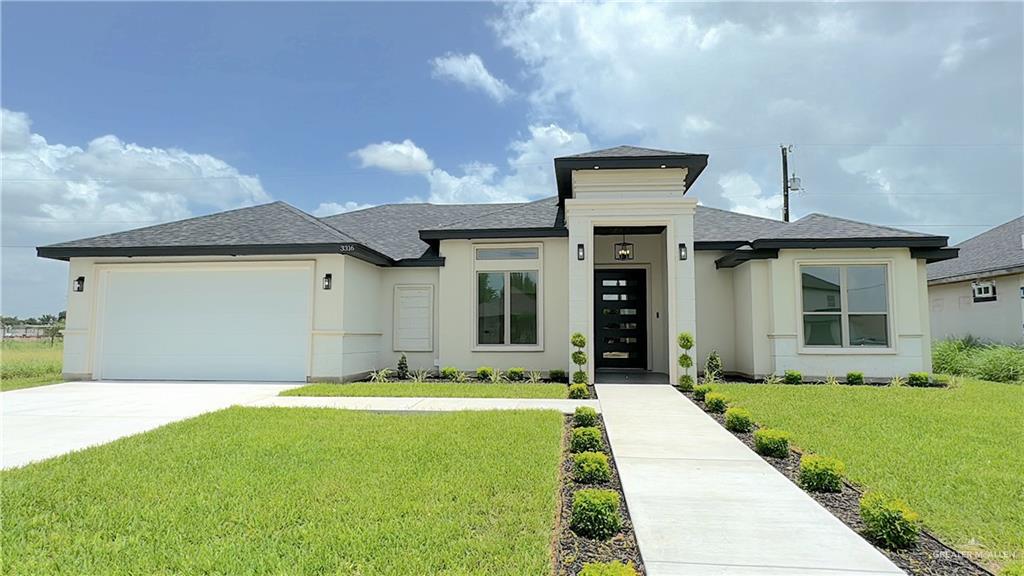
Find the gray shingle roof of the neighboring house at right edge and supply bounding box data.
[928,216,1024,281]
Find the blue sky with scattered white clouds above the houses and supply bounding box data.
[0,3,1024,316]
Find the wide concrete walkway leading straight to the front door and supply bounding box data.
[597,384,903,576]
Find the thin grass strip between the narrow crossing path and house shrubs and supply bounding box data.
[281,382,568,398]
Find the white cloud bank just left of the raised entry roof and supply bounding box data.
[357,124,591,204]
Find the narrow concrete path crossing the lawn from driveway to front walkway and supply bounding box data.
[249,396,601,414]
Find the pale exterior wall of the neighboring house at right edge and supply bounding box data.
[928,275,1024,343]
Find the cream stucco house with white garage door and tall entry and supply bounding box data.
[38,147,955,380]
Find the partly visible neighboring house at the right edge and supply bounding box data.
[928,216,1024,343]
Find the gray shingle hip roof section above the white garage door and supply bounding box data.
[46,202,353,248]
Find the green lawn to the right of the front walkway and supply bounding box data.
[714,379,1024,567]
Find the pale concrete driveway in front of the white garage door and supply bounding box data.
[0,382,300,468]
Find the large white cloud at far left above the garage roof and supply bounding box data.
[0,109,270,316]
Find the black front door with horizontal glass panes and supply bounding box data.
[594,270,647,368]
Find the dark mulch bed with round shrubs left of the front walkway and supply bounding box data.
[554,412,646,576]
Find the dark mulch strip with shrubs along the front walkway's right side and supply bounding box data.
[681,385,993,576]
